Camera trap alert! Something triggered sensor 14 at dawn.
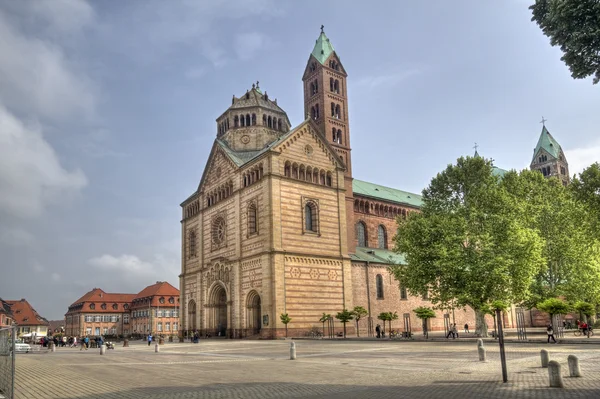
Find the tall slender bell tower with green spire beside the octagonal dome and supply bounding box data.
[302,25,355,253]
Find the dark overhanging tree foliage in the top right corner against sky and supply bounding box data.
[529,0,600,84]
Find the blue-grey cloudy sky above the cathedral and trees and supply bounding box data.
[0,0,600,319]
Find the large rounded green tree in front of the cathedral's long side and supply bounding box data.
[390,156,543,337]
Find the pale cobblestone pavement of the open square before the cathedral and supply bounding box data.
[10,339,600,399]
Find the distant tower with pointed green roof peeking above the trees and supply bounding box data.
[529,118,570,186]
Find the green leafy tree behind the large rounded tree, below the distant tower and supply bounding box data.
[501,170,600,307]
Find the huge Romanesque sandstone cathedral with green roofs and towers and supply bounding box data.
[180,31,568,338]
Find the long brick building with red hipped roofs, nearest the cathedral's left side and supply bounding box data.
[65,281,179,336]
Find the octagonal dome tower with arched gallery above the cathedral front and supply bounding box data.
[217,82,290,151]
